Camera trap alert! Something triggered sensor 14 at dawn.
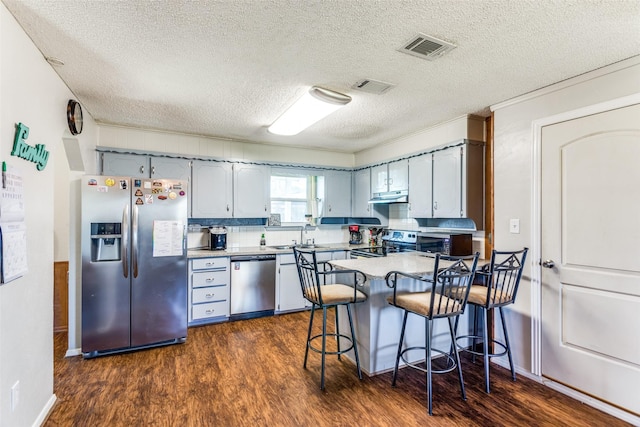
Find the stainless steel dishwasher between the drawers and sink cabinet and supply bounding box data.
[231,255,276,318]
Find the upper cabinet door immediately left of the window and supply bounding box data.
[233,163,271,218]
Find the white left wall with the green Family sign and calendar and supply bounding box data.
[0,5,95,426]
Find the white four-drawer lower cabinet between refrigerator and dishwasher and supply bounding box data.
[189,257,231,326]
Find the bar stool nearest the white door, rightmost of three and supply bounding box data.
[456,248,529,393]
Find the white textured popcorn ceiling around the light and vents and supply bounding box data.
[3,0,640,152]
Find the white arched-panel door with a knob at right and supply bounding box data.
[541,104,640,414]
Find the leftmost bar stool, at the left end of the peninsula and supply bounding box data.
[293,248,367,390]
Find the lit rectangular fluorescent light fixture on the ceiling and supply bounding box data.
[268,86,351,136]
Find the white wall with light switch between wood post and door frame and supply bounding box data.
[492,57,640,372]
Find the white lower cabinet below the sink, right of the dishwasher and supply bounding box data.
[276,251,332,312]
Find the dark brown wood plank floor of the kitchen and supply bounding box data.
[45,312,627,427]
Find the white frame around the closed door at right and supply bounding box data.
[530,93,640,424]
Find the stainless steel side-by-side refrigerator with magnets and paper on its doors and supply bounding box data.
[81,176,188,357]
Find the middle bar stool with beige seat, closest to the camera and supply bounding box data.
[386,252,479,415]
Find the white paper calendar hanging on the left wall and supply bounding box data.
[0,162,27,283]
